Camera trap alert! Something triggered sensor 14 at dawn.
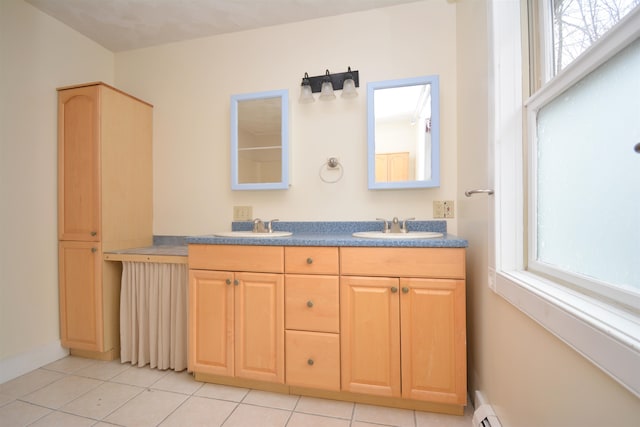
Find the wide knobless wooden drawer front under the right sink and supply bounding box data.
[340,248,465,279]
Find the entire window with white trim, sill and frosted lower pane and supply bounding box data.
[490,0,640,397]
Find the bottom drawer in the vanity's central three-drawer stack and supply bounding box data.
[285,331,340,390]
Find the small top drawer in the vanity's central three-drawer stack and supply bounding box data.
[284,246,340,274]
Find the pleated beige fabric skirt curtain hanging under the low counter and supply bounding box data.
[120,261,188,371]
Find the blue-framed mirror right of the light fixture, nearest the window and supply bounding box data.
[367,76,440,190]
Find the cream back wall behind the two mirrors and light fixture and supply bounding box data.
[116,0,457,234]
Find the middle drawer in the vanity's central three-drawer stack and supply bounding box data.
[284,274,340,332]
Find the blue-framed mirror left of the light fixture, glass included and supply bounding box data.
[231,90,289,190]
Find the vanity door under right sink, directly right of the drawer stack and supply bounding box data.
[340,276,400,397]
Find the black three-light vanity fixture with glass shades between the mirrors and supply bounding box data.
[298,67,360,104]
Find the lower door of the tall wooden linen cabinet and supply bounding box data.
[58,242,103,351]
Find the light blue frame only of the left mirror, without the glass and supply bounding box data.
[231,89,289,190]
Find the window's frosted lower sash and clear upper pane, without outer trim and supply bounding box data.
[528,0,640,309]
